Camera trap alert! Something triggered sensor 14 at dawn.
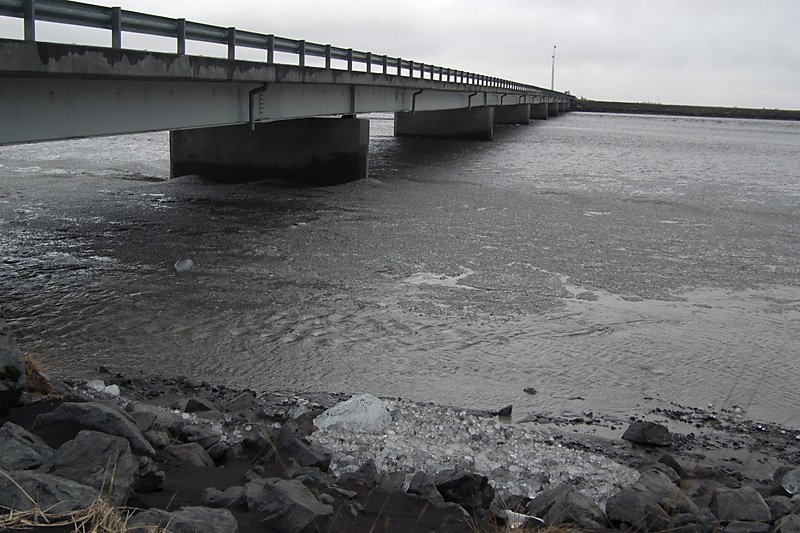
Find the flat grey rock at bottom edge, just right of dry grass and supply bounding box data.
[127,507,239,533]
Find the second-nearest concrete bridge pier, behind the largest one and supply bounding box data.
[394,107,494,141]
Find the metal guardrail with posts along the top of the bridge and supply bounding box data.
[0,0,550,94]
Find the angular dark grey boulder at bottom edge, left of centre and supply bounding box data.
[244,478,333,533]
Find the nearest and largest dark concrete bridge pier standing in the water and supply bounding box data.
[169,118,369,185]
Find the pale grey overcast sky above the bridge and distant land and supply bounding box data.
[0,0,800,109]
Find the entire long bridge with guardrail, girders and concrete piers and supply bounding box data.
[0,0,574,184]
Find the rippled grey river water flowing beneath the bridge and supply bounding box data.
[0,113,800,427]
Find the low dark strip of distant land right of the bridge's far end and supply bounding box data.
[571,99,800,120]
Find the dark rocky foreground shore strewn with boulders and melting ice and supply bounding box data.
[0,318,800,533]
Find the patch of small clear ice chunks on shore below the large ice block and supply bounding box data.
[311,400,638,503]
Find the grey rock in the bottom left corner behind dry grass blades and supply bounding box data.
[0,470,98,514]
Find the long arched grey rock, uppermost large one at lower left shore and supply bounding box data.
[33,402,156,457]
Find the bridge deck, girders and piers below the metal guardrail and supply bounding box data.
[0,40,568,184]
